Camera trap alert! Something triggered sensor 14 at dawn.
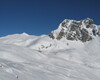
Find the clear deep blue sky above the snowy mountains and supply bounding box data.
[0,0,100,36]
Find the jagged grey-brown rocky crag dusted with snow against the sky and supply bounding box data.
[49,18,100,42]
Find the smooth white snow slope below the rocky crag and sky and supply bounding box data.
[0,33,100,80]
